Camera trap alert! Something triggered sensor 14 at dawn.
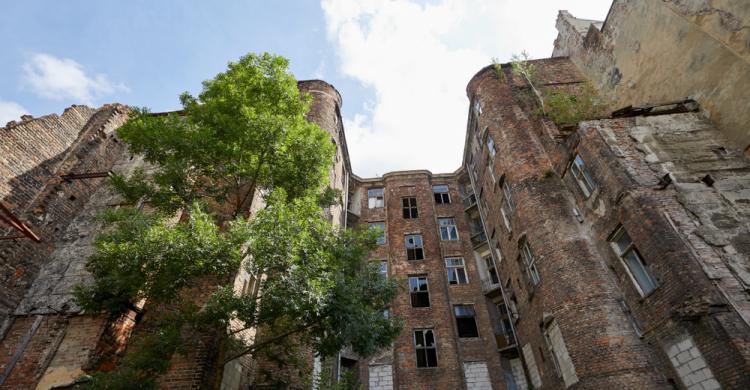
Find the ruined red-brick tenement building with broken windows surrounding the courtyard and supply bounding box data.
[0,0,750,390]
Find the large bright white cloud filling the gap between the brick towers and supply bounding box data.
[321,0,609,177]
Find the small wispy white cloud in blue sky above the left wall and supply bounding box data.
[23,53,129,104]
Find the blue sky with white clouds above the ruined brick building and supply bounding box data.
[0,0,610,177]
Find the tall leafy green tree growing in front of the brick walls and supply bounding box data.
[76,54,400,389]
